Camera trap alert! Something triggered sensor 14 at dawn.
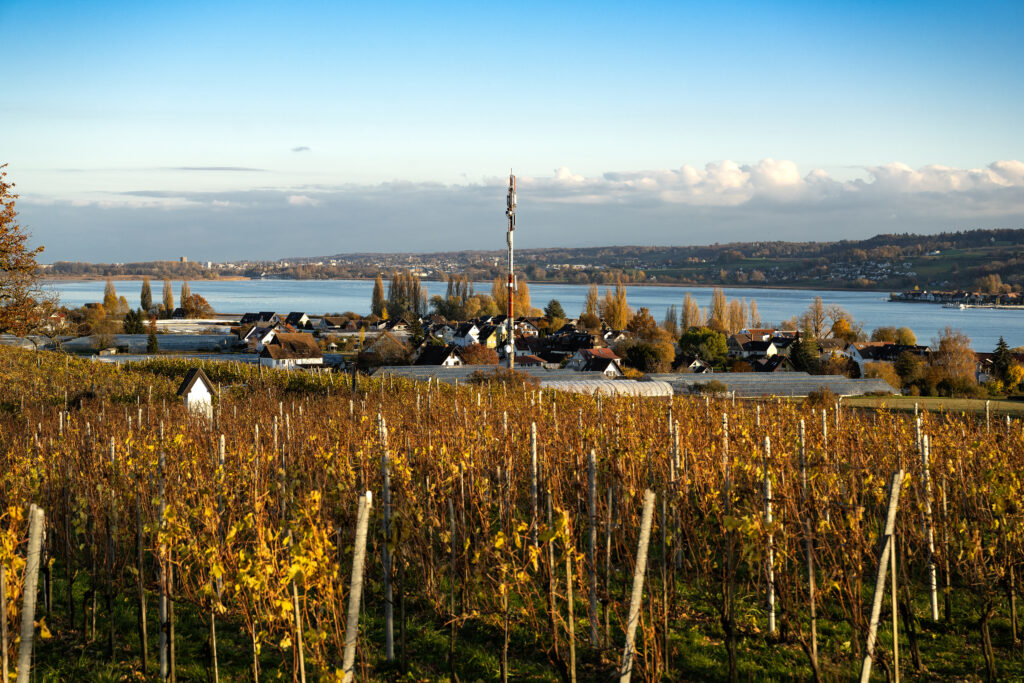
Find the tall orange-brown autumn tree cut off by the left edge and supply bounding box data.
[0,164,50,335]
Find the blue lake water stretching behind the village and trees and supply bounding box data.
[48,280,1024,351]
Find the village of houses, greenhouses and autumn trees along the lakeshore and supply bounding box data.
[16,272,1024,397]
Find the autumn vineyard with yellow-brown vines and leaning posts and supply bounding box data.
[0,350,1024,682]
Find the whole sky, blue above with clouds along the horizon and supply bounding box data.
[0,0,1024,262]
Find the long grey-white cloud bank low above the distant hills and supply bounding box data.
[18,159,1024,261]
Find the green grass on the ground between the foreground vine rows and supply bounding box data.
[25,557,1024,682]
